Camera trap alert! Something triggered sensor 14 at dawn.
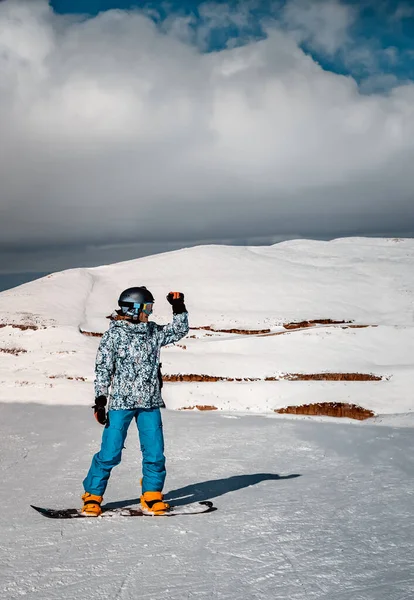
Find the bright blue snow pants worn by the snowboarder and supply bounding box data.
[83,408,166,496]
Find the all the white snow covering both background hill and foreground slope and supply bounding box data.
[0,238,414,600]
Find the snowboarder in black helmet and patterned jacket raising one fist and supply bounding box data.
[82,286,188,517]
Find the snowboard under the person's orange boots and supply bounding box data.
[30,501,217,519]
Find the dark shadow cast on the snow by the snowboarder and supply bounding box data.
[105,473,300,508]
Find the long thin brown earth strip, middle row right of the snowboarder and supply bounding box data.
[163,373,384,383]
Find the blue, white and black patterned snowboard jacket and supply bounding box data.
[95,312,188,410]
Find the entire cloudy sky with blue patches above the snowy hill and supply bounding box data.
[0,0,414,285]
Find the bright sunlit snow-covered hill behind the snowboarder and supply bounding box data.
[0,238,414,413]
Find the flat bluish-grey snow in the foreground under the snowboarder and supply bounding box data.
[0,404,414,600]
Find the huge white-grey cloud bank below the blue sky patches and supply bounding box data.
[0,0,414,268]
